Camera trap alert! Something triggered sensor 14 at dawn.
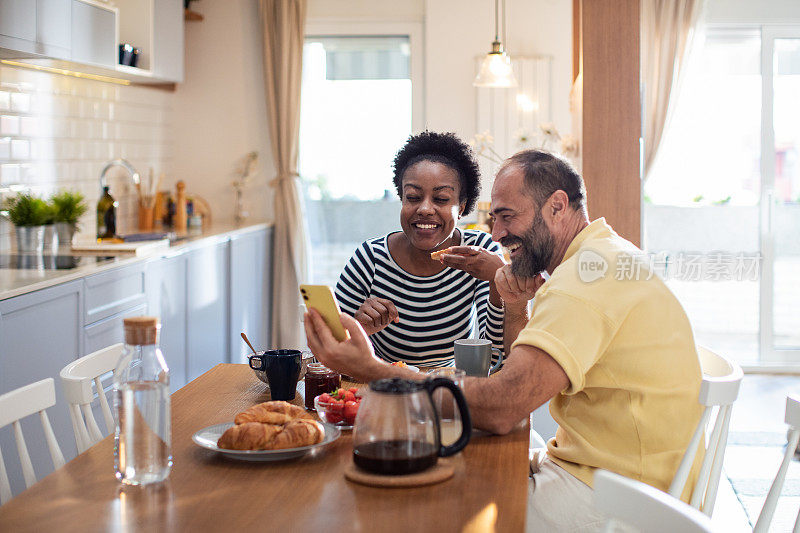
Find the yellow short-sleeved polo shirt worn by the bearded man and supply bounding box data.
[513,218,702,499]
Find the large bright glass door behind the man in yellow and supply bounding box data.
[642,25,800,367]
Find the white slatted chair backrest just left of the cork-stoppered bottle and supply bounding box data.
[60,344,123,453]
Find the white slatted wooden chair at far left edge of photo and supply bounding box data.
[0,378,64,504]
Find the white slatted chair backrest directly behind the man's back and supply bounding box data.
[669,346,744,516]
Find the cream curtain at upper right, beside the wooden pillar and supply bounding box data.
[641,0,704,180]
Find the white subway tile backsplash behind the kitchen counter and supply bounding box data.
[0,65,174,242]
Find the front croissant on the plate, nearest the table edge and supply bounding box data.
[217,419,325,450]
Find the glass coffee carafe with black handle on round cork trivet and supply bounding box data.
[353,378,472,474]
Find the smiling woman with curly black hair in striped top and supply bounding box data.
[336,131,503,367]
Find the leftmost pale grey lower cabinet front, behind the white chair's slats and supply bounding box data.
[0,280,83,494]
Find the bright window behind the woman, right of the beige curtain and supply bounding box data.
[298,25,421,285]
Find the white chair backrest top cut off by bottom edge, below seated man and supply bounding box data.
[593,470,715,533]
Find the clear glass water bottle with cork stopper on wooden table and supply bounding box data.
[114,316,172,485]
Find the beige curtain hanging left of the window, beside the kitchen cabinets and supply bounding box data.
[259,0,308,348]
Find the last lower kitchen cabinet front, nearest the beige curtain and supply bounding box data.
[230,229,272,363]
